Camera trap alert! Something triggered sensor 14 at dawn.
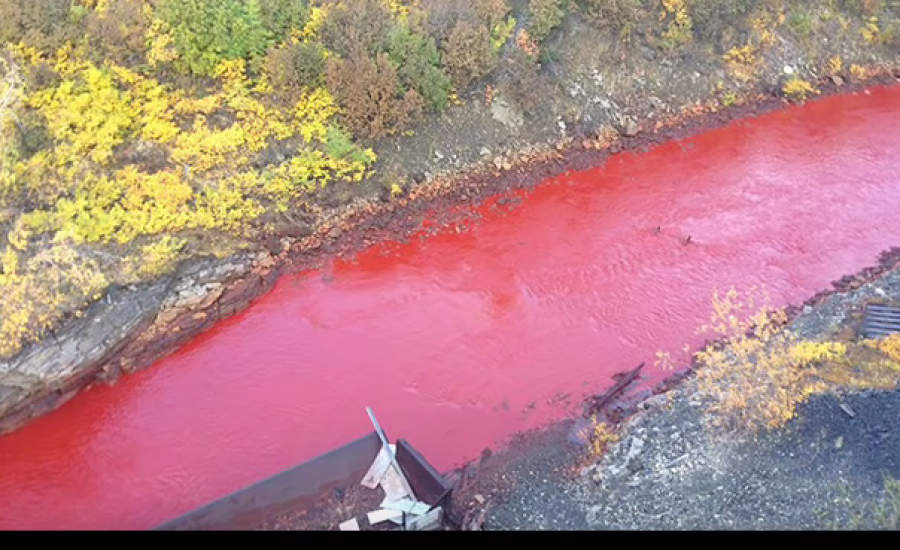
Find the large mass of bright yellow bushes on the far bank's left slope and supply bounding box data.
[0,41,375,355]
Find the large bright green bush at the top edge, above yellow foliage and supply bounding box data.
[159,0,271,76]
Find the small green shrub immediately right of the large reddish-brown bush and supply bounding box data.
[388,26,451,111]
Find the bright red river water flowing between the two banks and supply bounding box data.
[0,88,900,529]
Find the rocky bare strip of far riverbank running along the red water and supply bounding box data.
[0,0,896,440]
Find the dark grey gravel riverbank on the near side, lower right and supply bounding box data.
[444,249,900,530]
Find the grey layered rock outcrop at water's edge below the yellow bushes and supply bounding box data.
[0,252,277,435]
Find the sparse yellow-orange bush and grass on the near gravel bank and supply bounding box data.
[657,289,900,430]
